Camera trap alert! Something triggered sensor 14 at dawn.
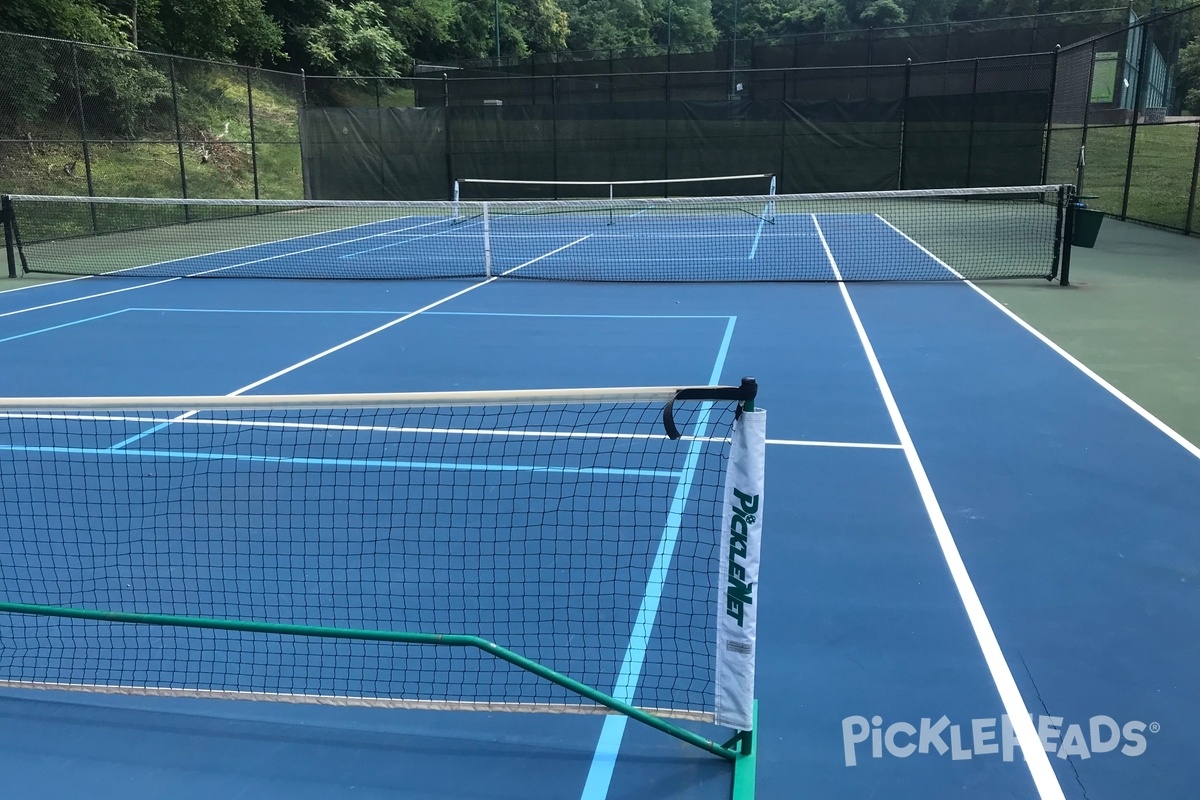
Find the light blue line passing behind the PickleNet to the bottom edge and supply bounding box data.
[580,317,737,800]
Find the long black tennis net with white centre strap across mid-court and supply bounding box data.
[5,186,1070,282]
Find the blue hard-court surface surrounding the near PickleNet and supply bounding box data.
[0,208,1200,800]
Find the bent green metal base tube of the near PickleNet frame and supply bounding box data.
[0,602,744,762]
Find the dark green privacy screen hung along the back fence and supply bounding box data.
[301,55,1052,200]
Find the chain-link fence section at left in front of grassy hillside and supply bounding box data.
[0,34,304,211]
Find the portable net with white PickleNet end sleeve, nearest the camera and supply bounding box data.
[0,379,764,762]
